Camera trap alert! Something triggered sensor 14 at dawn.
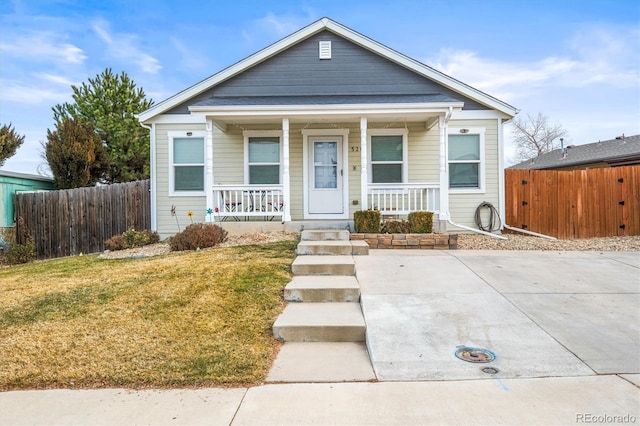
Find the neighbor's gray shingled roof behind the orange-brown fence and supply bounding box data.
[509,135,640,170]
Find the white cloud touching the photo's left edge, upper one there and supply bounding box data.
[0,32,87,64]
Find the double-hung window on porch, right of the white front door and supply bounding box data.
[369,129,407,183]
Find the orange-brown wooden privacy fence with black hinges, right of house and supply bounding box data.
[505,166,640,239]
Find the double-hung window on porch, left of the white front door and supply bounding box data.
[245,133,281,185]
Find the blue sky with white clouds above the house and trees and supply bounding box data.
[0,0,640,173]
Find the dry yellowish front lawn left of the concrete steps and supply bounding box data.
[0,241,295,390]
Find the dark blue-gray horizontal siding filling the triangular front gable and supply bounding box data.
[169,31,488,114]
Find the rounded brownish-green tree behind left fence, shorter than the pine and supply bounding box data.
[45,118,109,189]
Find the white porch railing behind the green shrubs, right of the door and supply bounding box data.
[367,183,440,215]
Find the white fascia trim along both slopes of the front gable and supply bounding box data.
[138,18,519,123]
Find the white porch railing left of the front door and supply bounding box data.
[213,185,284,222]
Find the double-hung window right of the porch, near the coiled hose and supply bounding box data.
[448,129,484,191]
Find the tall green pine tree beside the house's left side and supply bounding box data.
[53,68,153,183]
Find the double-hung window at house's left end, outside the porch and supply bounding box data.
[169,132,205,195]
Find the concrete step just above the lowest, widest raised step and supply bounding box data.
[284,276,360,303]
